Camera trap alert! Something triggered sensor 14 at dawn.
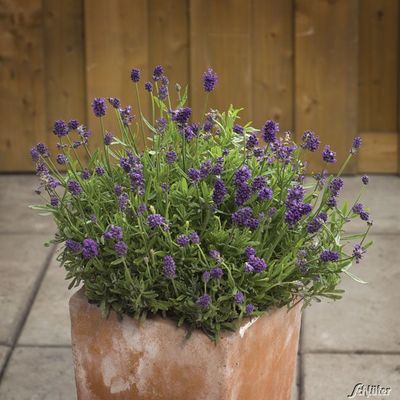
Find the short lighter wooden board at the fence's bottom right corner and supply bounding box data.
[358,132,399,174]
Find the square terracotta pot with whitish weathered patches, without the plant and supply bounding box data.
[70,290,301,400]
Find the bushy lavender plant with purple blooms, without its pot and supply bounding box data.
[31,66,371,339]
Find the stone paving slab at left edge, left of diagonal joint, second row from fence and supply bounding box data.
[0,234,52,344]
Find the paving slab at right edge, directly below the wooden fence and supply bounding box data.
[340,175,400,233]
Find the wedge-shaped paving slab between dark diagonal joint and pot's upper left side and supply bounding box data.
[19,255,72,346]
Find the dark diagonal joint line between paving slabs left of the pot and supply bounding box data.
[0,245,57,385]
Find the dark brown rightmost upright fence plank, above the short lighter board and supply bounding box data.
[359,0,399,132]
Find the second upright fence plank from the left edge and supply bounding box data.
[43,0,86,161]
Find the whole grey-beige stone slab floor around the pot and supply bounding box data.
[0,175,400,400]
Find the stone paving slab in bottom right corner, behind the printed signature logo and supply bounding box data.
[303,354,400,400]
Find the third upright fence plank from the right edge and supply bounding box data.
[252,0,294,131]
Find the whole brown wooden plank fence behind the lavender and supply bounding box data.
[0,0,400,173]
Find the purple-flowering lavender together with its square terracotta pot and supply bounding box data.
[31,66,371,400]
